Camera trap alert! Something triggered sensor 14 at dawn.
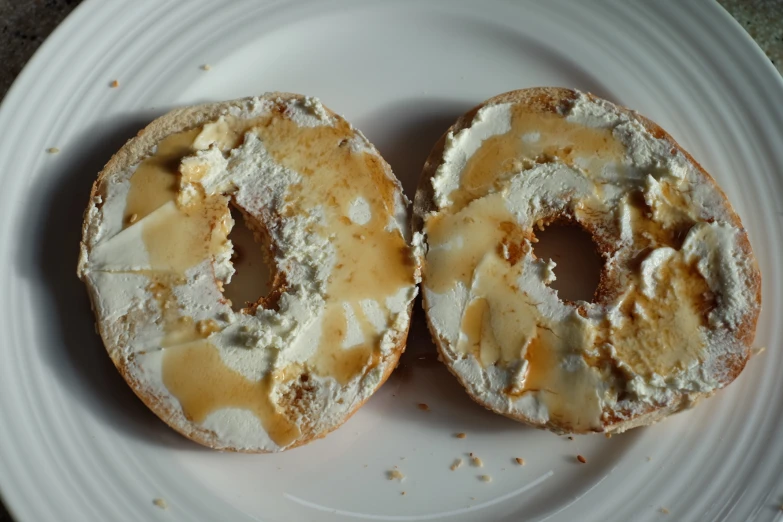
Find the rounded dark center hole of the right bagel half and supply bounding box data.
[533,222,603,302]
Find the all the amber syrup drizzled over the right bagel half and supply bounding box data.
[424,100,714,431]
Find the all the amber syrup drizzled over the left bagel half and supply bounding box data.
[119,102,414,446]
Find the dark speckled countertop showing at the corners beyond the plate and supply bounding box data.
[0,0,783,522]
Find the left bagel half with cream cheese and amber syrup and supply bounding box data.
[78,93,419,453]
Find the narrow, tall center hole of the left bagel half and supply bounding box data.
[223,205,272,312]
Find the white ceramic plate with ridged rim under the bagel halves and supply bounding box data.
[0,0,783,522]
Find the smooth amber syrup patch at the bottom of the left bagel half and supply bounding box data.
[163,341,299,446]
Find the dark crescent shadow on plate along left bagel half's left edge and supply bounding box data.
[20,110,207,447]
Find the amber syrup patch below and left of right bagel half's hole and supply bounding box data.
[450,252,601,431]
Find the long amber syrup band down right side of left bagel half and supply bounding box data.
[255,118,414,384]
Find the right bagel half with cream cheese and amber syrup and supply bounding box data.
[413,88,761,433]
